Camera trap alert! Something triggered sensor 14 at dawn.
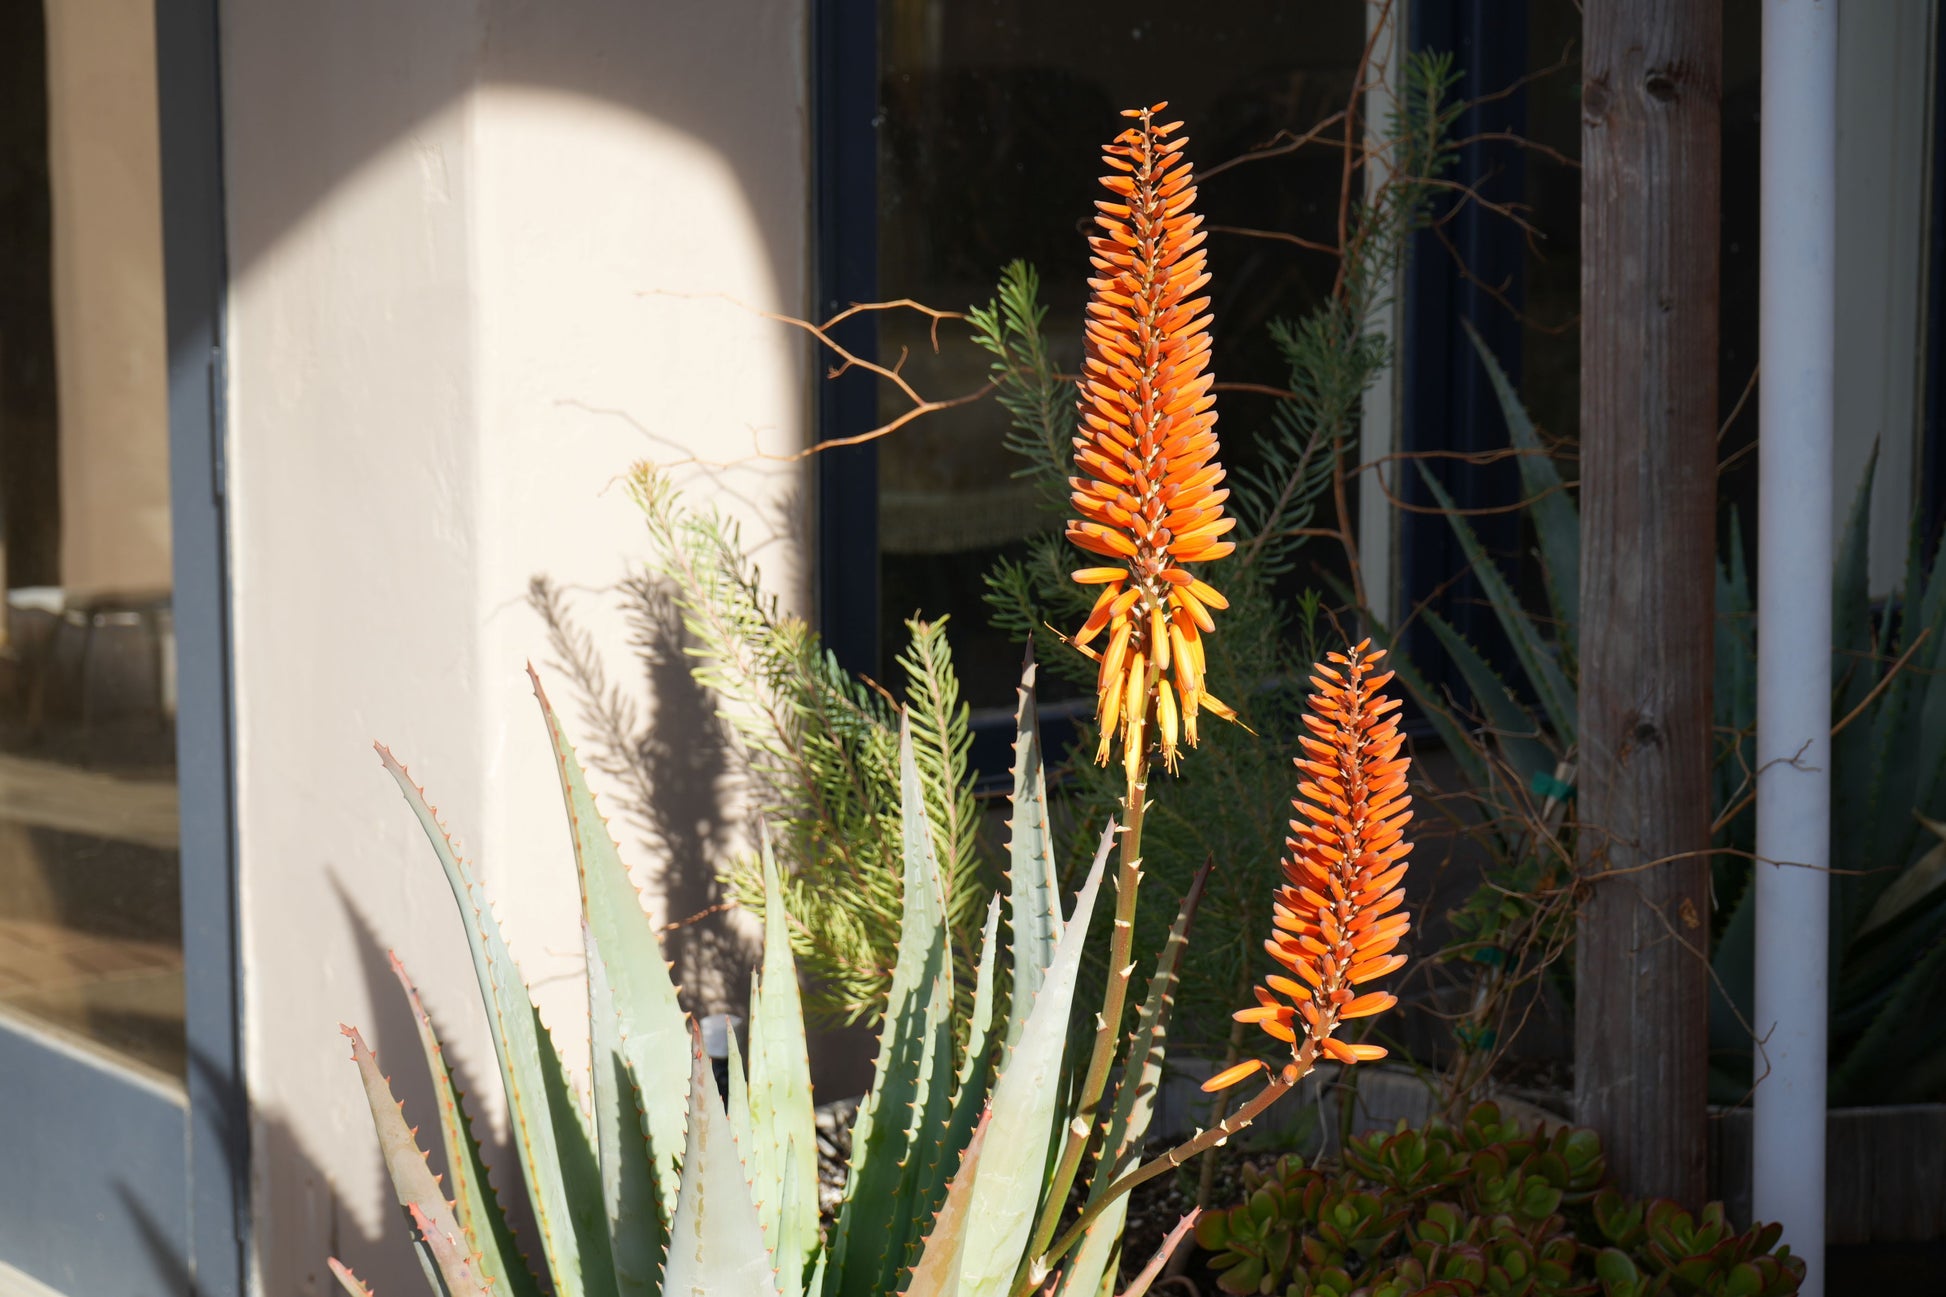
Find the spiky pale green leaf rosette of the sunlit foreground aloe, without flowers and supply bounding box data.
[333,664,1222,1297]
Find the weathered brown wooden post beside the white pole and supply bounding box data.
[1574,0,1722,1205]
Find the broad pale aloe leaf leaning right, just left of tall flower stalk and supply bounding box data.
[959,822,1115,1297]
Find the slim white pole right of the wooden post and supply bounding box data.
[1751,0,1837,1297]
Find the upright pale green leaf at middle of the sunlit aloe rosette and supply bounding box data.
[743,834,817,1283]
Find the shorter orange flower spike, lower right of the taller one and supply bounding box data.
[1203,641,1413,1091]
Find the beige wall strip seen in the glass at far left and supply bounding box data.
[47,0,169,596]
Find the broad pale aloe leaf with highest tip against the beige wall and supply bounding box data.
[527,666,689,1219]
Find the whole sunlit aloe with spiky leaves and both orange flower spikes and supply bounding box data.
[333,105,1411,1297]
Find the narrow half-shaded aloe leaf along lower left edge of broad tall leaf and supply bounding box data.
[582,923,667,1297]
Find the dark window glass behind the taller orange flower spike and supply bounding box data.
[878,0,1366,715]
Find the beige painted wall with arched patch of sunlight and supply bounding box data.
[224,0,810,1295]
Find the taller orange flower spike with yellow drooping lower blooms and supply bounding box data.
[1068,103,1236,779]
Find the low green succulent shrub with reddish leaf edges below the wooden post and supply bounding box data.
[1197,1102,1804,1297]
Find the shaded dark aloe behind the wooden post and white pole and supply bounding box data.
[1408,323,1946,1106]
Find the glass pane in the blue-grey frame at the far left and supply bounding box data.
[0,0,183,1077]
